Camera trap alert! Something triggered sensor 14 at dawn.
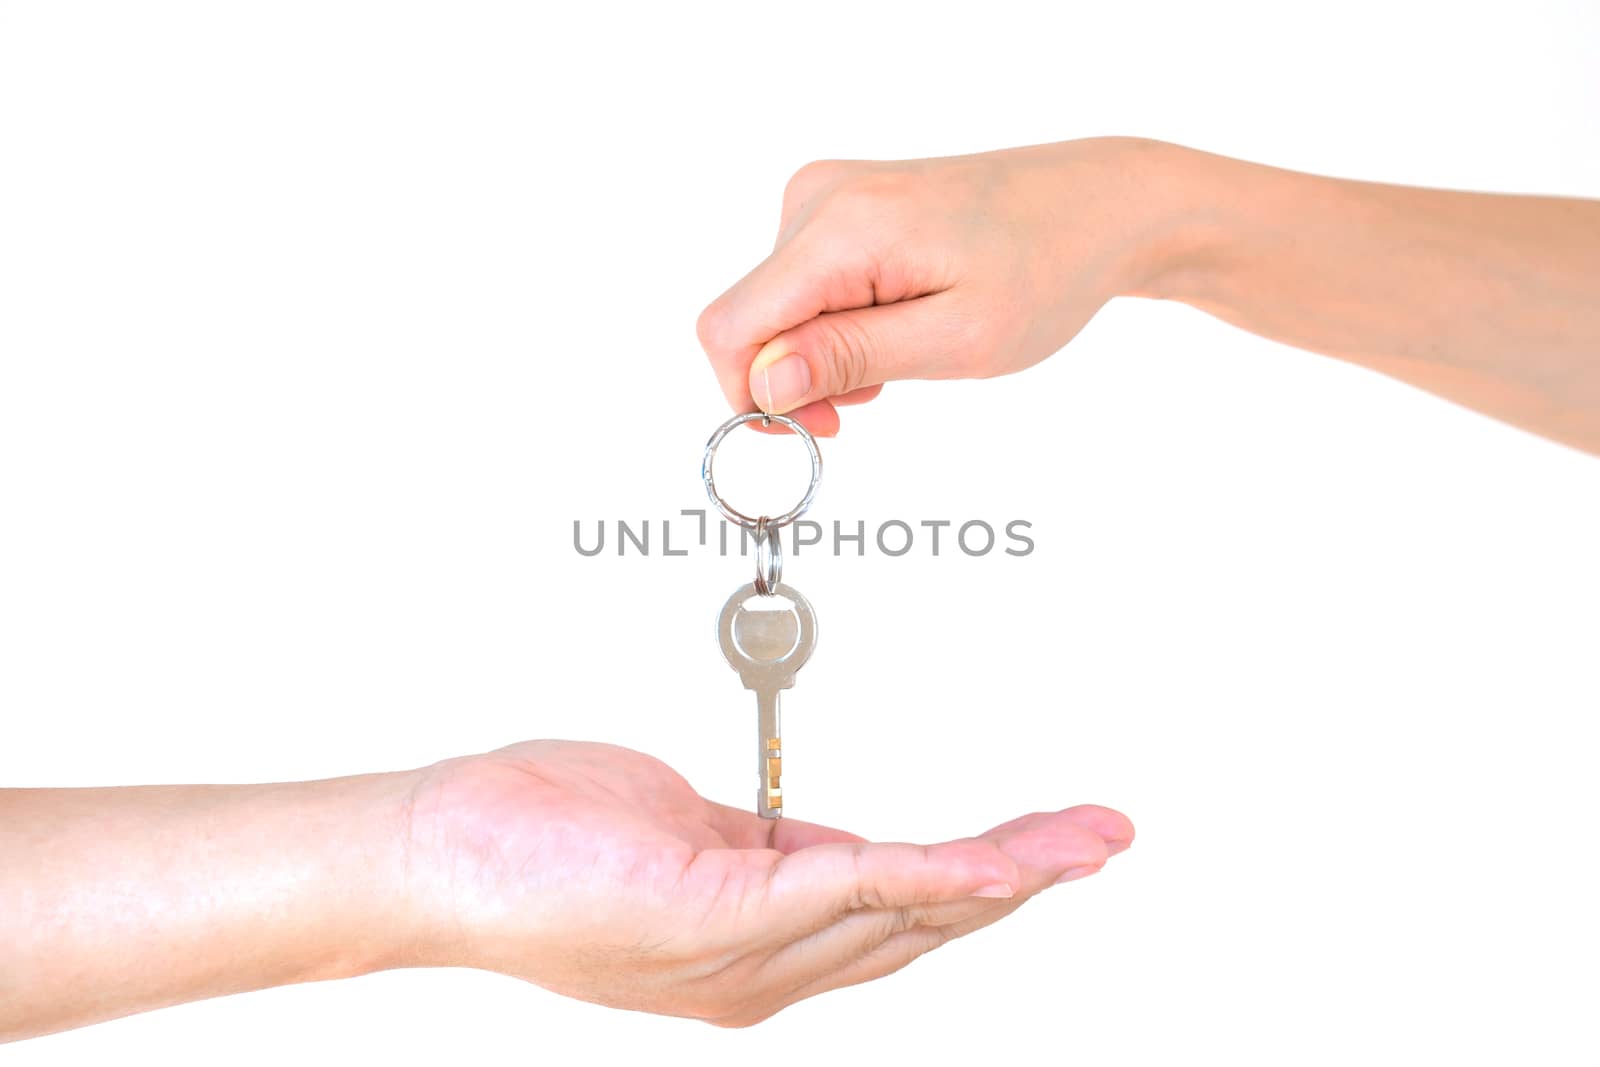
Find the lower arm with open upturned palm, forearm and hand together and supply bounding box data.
[0,741,1133,1040]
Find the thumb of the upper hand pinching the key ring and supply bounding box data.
[749,293,973,414]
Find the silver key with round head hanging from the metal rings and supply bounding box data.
[717,582,816,819]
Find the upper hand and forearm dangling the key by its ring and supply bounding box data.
[699,138,1600,453]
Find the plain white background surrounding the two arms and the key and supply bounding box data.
[0,0,1600,1067]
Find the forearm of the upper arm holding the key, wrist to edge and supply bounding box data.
[1139,140,1600,453]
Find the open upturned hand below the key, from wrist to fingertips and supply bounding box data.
[412,741,1131,1022]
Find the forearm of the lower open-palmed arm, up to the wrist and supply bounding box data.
[0,774,422,1040]
